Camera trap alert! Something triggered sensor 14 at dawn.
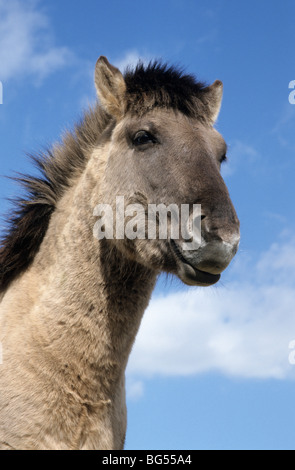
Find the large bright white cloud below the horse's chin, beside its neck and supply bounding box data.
[128,235,295,379]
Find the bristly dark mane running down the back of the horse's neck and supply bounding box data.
[0,106,110,294]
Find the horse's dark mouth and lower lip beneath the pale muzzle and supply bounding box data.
[170,239,220,287]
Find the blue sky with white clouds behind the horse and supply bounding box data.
[0,0,295,449]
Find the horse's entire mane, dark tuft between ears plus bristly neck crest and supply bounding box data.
[0,61,208,294]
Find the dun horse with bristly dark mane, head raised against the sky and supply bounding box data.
[0,56,240,450]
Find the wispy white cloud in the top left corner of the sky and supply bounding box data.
[0,0,72,81]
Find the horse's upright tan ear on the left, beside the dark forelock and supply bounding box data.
[95,56,126,119]
